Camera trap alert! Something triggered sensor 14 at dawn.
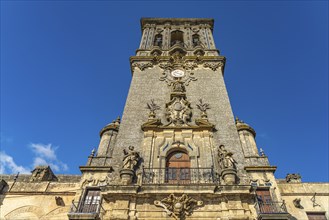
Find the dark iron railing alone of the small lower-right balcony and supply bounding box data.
[256,201,288,214]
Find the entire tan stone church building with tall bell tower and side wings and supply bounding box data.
[0,18,329,220]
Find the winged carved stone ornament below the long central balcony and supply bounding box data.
[154,194,203,220]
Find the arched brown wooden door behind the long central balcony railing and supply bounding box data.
[166,151,191,184]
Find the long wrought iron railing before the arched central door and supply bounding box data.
[142,168,219,185]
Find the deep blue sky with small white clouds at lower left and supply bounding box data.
[0,1,329,182]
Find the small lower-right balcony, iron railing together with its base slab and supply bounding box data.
[255,201,290,220]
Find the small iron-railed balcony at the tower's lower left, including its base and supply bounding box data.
[68,201,101,220]
